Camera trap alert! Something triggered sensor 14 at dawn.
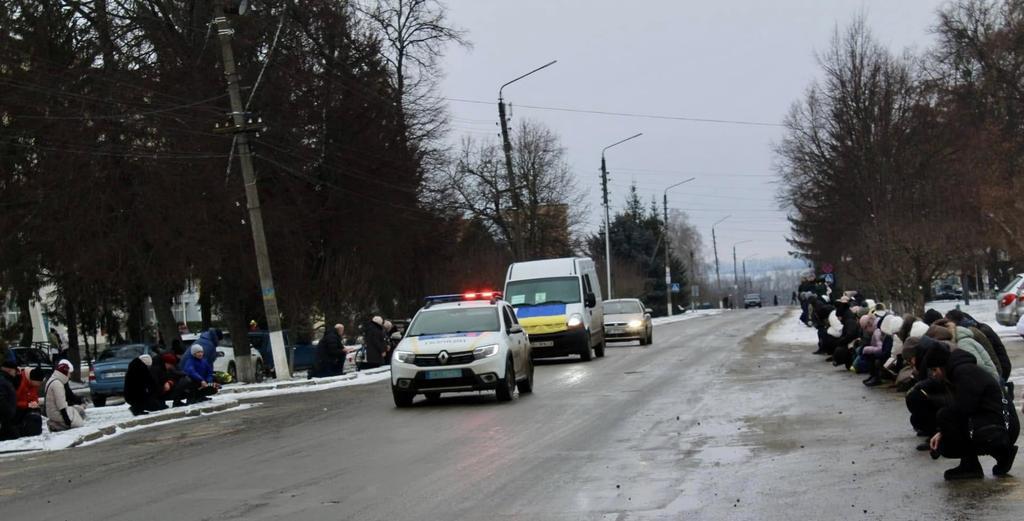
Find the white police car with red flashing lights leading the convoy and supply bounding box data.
[391,292,534,407]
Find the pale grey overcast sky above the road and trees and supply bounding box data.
[442,0,945,259]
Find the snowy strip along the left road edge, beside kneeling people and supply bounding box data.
[0,367,391,458]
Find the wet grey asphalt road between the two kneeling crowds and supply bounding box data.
[0,308,1024,521]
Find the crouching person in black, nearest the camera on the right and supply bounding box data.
[925,349,1020,480]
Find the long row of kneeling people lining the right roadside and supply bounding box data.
[799,277,1020,480]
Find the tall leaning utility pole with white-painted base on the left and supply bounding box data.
[213,2,292,379]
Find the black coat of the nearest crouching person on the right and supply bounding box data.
[945,349,1004,429]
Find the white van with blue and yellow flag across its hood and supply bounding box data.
[503,257,604,361]
